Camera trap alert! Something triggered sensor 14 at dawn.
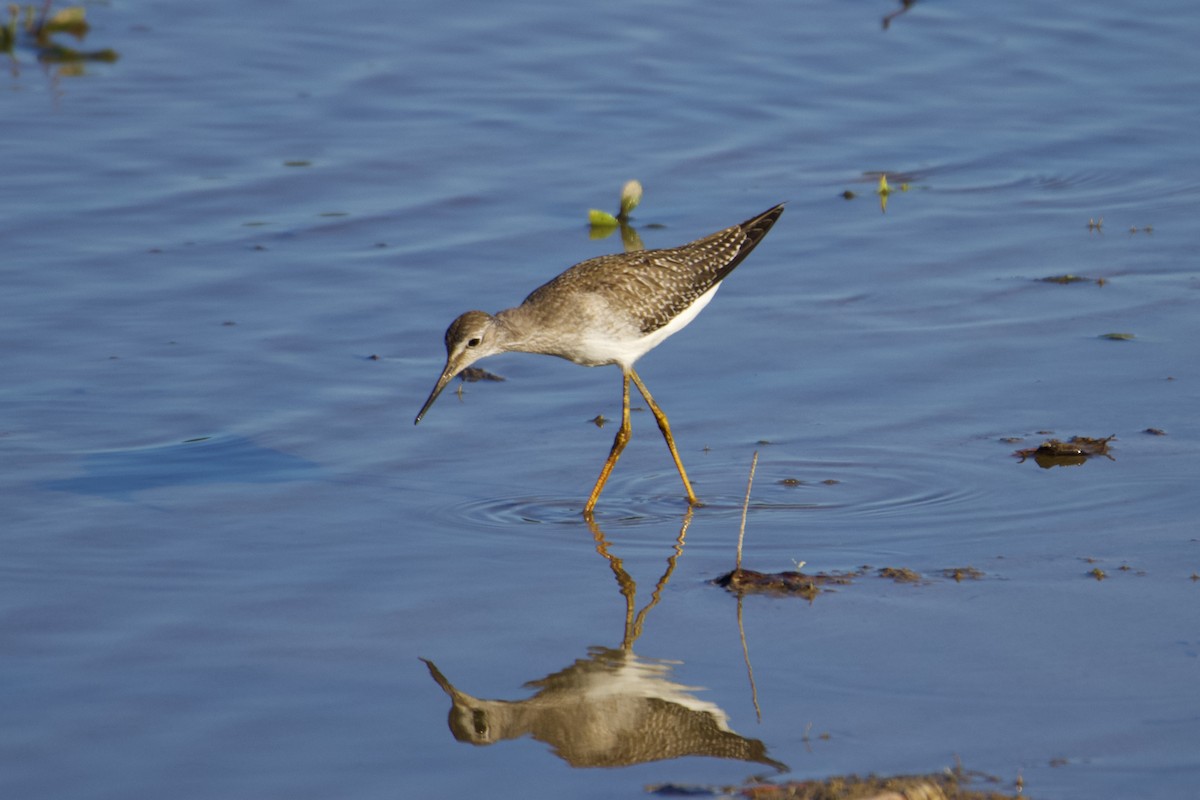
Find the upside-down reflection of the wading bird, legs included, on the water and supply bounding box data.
[422,511,788,772]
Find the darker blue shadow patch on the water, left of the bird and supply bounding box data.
[40,435,323,500]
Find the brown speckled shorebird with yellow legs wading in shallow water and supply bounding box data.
[413,204,784,517]
